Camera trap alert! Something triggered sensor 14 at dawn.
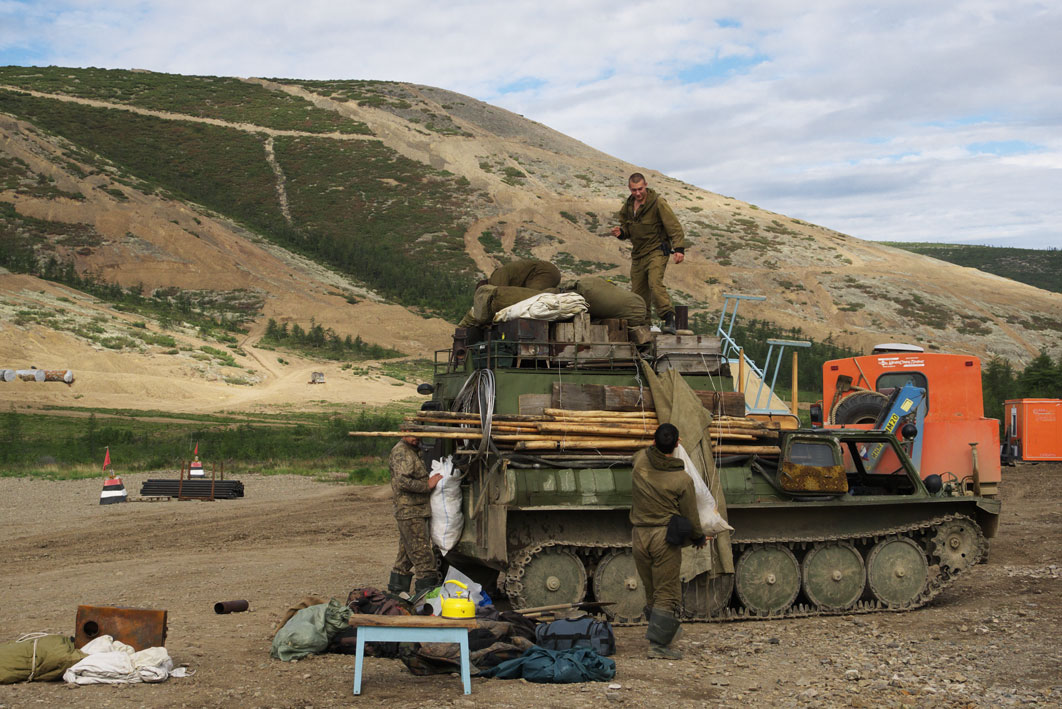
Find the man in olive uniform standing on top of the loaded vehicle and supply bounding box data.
[612,172,686,334]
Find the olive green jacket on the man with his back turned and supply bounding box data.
[631,446,704,537]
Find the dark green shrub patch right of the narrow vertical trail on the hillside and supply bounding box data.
[274,137,476,321]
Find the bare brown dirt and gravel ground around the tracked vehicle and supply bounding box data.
[0,464,1062,709]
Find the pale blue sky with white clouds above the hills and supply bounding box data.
[0,0,1062,248]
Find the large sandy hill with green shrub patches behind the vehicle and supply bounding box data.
[0,67,1062,426]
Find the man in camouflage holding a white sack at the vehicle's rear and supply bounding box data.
[388,435,443,595]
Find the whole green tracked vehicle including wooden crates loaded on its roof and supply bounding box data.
[425,321,999,623]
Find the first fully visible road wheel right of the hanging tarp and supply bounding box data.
[734,544,800,616]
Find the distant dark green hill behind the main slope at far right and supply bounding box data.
[884,241,1062,293]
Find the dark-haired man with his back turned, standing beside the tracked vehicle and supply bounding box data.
[631,423,707,660]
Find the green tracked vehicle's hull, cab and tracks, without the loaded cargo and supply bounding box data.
[431,324,999,622]
